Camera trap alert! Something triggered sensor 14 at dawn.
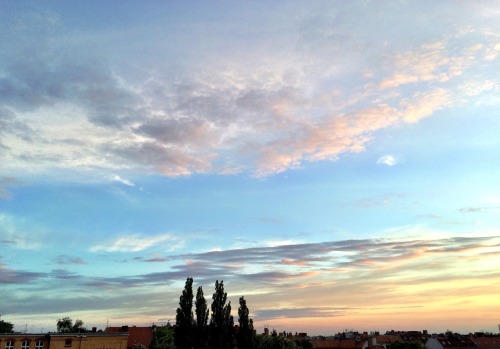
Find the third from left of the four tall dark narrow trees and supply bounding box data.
[210,280,234,349]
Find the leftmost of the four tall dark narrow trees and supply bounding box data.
[175,278,194,349]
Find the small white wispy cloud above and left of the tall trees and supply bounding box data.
[90,234,183,252]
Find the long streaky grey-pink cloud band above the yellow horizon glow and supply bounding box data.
[166,237,498,285]
